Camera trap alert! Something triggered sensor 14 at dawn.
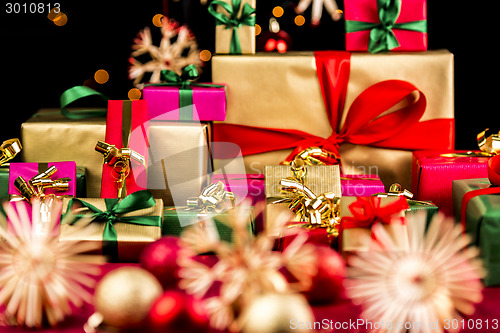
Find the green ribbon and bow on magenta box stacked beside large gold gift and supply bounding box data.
[145,65,224,120]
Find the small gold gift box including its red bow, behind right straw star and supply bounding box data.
[339,196,409,255]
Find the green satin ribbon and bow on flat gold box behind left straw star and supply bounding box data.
[61,190,162,262]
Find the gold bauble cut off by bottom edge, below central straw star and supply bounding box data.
[240,294,314,333]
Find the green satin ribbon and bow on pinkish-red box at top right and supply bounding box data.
[345,0,427,53]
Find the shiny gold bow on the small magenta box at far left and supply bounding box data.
[14,166,71,202]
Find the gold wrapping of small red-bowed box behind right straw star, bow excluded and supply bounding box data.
[339,196,409,254]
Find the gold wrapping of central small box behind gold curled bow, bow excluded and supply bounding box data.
[264,165,342,237]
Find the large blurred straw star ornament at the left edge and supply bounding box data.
[0,199,104,328]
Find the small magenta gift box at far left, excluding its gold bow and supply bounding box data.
[9,161,76,196]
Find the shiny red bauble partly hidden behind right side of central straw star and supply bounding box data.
[304,245,346,303]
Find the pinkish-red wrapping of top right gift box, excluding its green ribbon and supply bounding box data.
[344,0,427,51]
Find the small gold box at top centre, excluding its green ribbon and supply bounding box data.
[214,0,256,53]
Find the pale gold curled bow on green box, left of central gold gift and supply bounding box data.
[187,181,235,214]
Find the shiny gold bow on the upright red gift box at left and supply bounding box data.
[94,141,146,198]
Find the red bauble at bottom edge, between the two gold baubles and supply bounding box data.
[148,289,210,333]
